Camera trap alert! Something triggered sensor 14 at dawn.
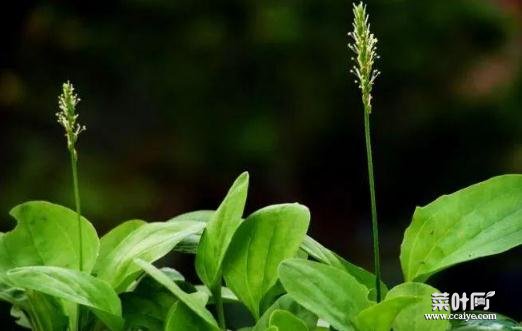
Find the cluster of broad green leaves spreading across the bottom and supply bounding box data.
[0,173,522,331]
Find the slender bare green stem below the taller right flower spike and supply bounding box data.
[364,104,381,302]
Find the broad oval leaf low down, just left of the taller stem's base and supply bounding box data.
[279,259,371,331]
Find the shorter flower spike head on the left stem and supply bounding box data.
[56,82,86,157]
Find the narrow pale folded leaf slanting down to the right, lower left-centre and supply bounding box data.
[134,259,219,330]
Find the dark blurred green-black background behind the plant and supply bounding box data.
[0,0,522,330]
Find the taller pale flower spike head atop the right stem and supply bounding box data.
[348,2,380,113]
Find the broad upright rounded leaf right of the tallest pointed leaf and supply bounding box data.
[224,204,310,320]
